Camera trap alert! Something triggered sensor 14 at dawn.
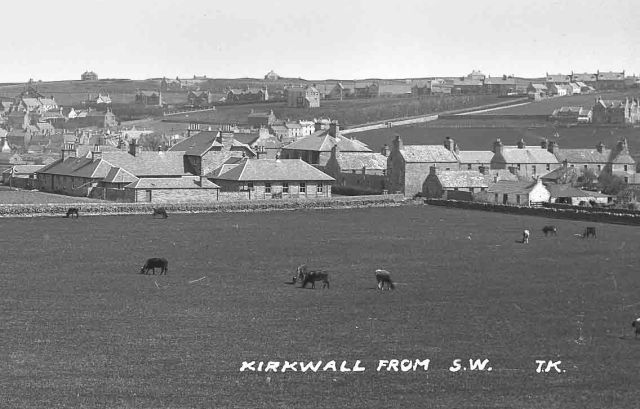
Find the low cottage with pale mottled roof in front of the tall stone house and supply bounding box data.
[422,166,489,201]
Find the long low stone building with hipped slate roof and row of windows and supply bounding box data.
[213,159,334,200]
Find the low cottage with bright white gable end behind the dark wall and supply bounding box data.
[476,179,551,206]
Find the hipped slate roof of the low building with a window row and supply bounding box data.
[216,159,335,182]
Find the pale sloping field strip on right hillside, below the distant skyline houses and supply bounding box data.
[478,88,640,115]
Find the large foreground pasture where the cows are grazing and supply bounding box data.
[0,206,640,409]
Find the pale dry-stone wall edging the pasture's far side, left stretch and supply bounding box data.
[0,194,408,218]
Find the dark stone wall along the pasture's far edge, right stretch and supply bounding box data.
[424,199,640,225]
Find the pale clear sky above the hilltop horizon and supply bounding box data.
[0,0,640,83]
